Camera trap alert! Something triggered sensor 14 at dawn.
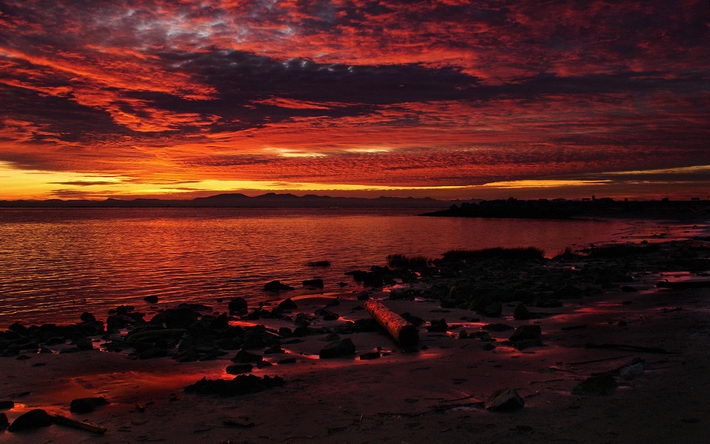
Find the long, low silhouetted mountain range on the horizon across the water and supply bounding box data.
[0,193,452,209]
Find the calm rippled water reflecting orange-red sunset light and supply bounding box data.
[0,208,696,328]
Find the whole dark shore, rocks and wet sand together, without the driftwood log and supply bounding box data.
[0,238,710,443]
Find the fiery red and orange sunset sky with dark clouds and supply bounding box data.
[0,0,710,200]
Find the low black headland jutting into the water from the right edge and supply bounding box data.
[424,198,710,221]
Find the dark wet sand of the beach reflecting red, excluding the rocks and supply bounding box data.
[0,241,710,443]
